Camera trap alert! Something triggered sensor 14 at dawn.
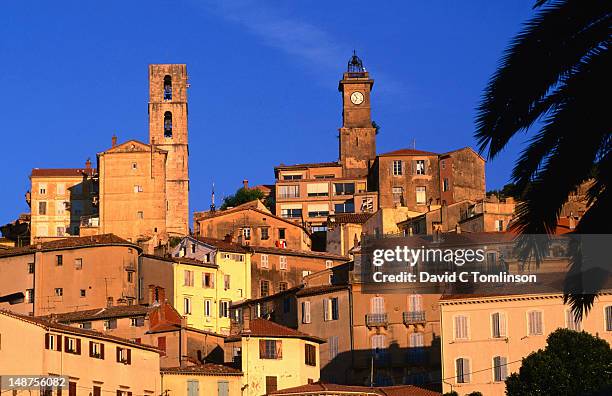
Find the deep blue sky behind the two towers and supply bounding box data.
[0,0,533,224]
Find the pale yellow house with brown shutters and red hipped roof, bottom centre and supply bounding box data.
[225,319,325,396]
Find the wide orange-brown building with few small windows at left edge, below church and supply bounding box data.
[0,234,141,316]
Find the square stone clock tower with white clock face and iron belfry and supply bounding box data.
[338,52,376,177]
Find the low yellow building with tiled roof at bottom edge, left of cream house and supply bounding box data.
[161,363,243,396]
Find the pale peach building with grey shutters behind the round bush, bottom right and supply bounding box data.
[440,292,612,396]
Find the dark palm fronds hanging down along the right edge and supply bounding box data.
[475,0,612,317]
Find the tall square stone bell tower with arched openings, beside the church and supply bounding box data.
[149,64,189,236]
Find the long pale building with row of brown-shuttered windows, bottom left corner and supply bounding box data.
[0,311,160,396]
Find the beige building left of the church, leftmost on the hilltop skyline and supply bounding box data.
[26,160,97,243]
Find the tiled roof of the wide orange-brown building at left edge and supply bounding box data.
[0,234,142,257]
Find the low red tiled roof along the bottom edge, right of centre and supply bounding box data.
[268,382,441,396]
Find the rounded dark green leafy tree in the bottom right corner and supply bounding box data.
[506,329,612,396]
